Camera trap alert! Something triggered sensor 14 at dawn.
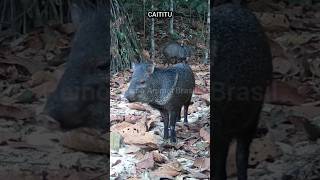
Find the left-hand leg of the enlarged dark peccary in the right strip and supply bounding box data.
[212,127,231,180]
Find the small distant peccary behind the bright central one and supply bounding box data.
[162,42,191,64]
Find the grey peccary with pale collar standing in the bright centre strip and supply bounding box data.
[124,63,195,143]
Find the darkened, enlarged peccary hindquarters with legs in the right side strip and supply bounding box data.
[210,3,272,180]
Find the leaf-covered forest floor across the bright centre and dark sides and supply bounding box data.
[0,1,320,180]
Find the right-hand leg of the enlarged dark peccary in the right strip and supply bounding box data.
[236,135,252,180]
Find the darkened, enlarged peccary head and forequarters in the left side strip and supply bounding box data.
[44,4,110,129]
